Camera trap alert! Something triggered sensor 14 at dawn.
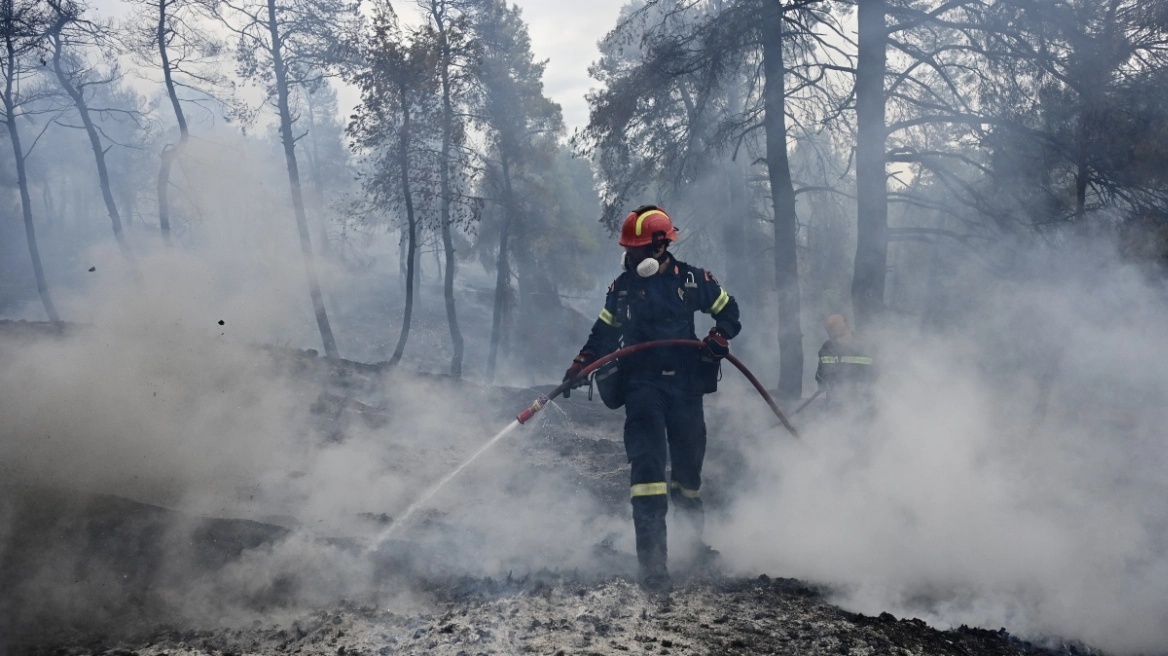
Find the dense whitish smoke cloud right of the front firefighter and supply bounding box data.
[711,241,1168,652]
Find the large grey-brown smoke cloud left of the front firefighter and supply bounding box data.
[0,126,631,640]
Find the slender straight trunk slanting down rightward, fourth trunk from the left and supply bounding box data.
[267,0,340,357]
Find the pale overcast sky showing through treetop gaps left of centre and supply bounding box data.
[91,0,628,133]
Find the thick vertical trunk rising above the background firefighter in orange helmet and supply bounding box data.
[851,0,888,327]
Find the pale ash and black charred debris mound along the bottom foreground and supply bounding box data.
[9,573,1069,656]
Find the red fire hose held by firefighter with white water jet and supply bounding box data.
[373,340,801,541]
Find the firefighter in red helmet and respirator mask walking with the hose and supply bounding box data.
[564,205,742,589]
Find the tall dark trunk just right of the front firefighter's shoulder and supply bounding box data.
[763,0,804,398]
